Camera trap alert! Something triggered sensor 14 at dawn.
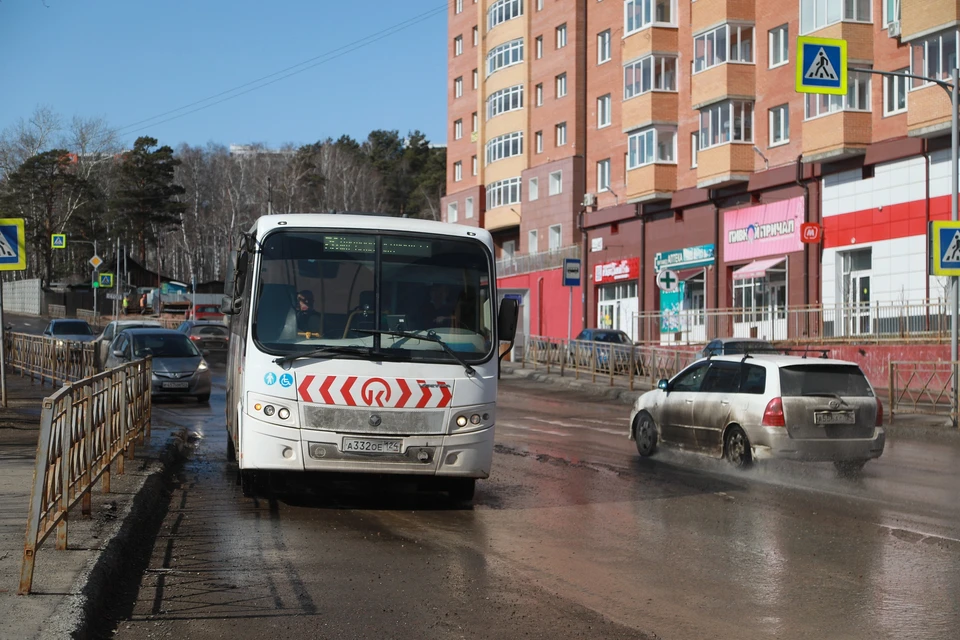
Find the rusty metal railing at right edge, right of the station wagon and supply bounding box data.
[887,361,960,424]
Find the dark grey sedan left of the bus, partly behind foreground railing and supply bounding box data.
[106,328,210,403]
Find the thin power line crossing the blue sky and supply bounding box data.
[117,2,452,135]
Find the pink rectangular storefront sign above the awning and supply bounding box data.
[723,197,803,263]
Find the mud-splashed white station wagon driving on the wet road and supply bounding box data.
[630,355,885,473]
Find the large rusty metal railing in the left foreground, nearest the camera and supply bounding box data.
[17,358,152,595]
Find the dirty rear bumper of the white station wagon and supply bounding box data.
[746,427,886,462]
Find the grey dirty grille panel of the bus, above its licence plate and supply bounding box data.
[303,404,446,436]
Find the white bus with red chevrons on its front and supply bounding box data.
[221,214,518,501]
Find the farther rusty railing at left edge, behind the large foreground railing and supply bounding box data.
[4,331,98,385]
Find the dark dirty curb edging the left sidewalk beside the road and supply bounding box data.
[40,428,187,640]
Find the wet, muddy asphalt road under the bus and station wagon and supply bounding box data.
[101,372,960,639]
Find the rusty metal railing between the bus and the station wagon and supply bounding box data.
[523,336,700,390]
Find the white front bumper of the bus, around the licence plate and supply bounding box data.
[238,415,494,478]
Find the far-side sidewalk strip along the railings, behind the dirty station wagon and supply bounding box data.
[502,361,960,438]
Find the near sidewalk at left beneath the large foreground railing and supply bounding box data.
[0,371,184,638]
